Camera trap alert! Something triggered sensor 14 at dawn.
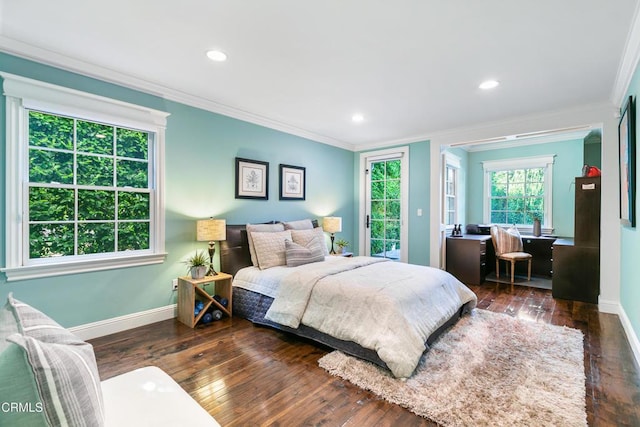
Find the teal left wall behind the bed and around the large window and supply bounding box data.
[0,53,356,327]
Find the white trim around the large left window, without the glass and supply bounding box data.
[0,72,169,281]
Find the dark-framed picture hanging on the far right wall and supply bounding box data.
[618,96,636,227]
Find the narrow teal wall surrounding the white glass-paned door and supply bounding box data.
[353,141,437,265]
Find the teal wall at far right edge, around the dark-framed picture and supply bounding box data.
[620,61,640,348]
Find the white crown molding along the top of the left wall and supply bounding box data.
[0,35,354,151]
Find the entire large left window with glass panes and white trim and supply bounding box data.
[2,74,167,280]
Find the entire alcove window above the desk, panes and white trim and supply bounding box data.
[483,156,553,228]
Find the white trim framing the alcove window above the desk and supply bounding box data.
[482,154,555,234]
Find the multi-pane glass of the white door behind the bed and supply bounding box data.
[365,157,404,261]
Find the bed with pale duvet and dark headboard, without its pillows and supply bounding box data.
[220,222,477,378]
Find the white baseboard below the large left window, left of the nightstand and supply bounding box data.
[69,304,176,340]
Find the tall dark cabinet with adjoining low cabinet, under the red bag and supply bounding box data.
[552,177,600,304]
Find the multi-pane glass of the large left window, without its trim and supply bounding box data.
[28,110,153,260]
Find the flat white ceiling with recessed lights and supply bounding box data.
[0,0,637,148]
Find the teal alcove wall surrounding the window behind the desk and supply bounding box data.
[466,139,584,237]
